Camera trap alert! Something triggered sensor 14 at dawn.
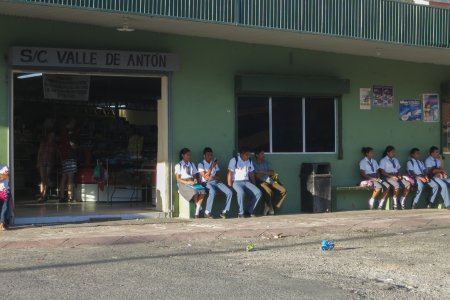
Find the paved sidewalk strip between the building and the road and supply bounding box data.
[0,209,450,249]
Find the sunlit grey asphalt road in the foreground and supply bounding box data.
[0,221,450,299]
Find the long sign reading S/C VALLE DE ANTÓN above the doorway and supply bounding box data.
[9,47,179,72]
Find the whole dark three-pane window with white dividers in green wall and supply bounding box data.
[237,96,337,153]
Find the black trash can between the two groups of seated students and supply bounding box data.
[300,163,331,213]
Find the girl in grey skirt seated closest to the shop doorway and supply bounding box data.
[175,148,206,218]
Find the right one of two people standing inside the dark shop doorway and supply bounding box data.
[58,119,78,202]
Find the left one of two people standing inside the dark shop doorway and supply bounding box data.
[37,131,57,202]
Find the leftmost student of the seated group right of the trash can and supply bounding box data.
[359,147,390,209]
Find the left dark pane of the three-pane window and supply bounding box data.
[238,97,270,152]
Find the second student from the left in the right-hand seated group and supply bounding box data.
[380,146,411,209]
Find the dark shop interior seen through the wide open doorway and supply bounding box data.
[13,72,161,217]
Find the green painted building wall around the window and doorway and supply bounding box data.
[0,16,450,215]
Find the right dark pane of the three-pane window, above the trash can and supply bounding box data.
[305,98,336,152]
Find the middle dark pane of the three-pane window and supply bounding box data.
[272,97,303,152]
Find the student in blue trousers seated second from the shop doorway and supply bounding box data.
[198,147,233,219]
